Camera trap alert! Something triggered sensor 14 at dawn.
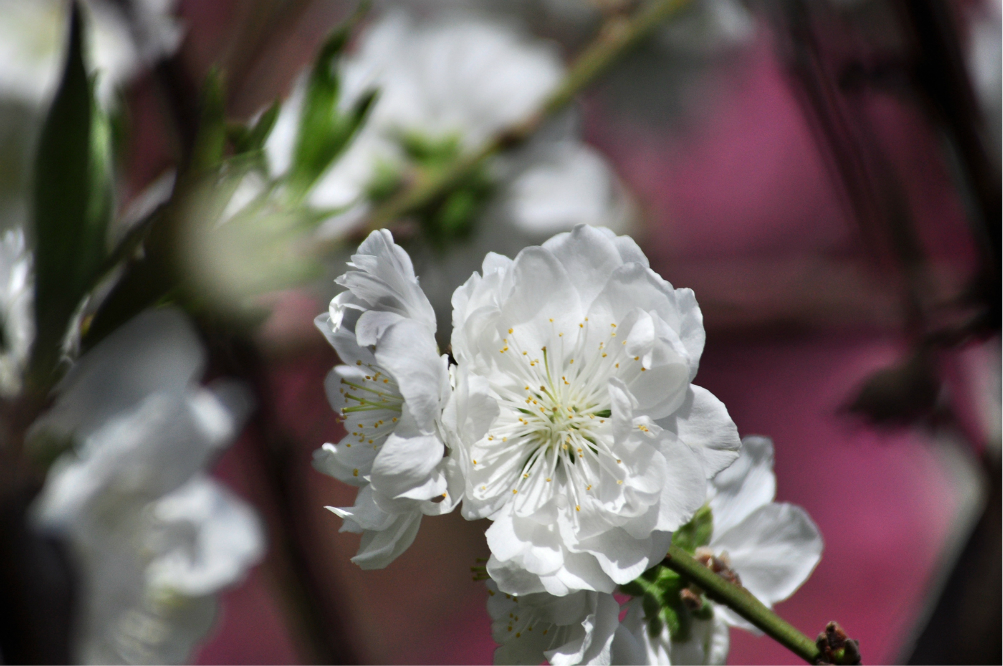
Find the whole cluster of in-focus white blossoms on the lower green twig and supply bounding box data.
[315,225,821,664]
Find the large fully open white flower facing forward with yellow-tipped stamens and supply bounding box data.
[449,226,739,596]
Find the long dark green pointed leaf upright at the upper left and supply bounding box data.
[29,4,113,386]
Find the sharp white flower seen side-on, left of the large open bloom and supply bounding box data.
[314,230,462,569]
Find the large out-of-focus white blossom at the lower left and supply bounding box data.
[29,310,264,663]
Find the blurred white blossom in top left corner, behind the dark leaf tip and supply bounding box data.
[0,0,182,105]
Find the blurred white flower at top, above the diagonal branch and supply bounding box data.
[266,12,564,214]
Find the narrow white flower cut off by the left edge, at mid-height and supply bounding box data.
[0,228,35,398]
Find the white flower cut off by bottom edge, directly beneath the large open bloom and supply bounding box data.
[487,581,620,666]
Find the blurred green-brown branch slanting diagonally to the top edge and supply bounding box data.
[365,0,688,232]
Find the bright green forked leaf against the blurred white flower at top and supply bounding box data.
[289,7,376,198]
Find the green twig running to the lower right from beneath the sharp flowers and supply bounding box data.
[662,546,822,664]
